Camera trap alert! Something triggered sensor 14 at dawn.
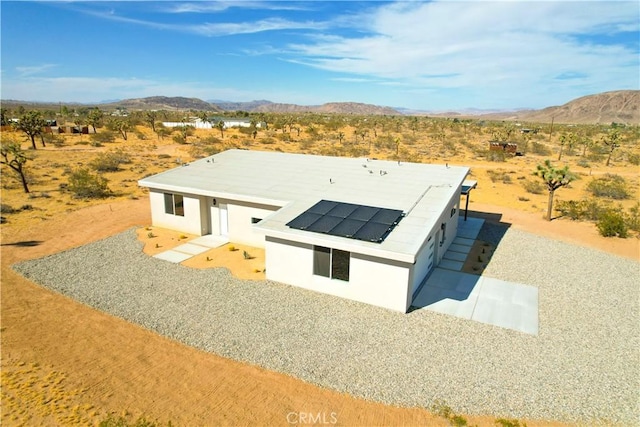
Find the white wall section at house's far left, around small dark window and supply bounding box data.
[149,189,202,235]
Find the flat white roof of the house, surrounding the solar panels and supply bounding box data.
[138,149,469,263]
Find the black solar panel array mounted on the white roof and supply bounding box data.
[287,200,404,243]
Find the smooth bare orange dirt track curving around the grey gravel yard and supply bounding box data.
[1,199,624,426]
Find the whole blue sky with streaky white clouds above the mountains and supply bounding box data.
[0,0,640,111]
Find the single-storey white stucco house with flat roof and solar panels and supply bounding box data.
[139,150,469,312]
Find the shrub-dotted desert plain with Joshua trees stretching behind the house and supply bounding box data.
[2,106,640,236]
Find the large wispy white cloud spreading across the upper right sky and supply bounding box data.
[287,2,638,102]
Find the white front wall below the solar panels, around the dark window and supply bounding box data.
[265,237,412,313]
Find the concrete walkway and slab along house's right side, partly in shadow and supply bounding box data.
[411,218,538,335]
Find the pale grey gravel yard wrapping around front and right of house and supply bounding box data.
[14,223,640,425]
